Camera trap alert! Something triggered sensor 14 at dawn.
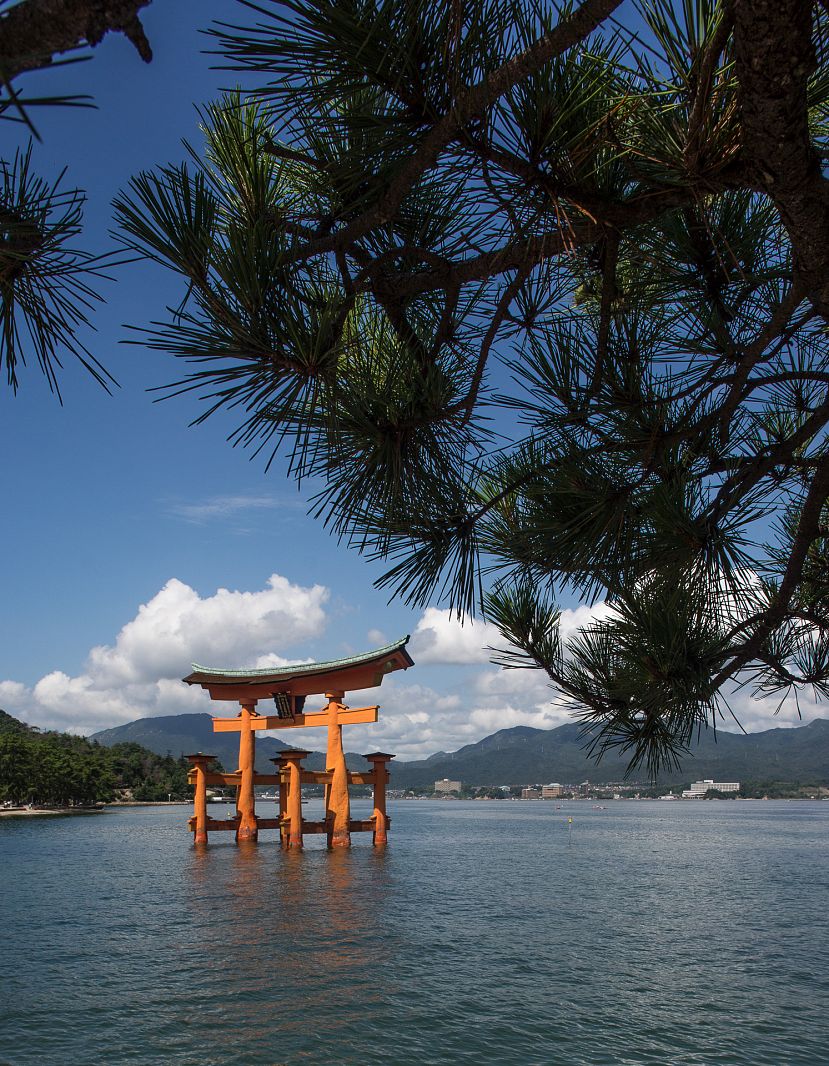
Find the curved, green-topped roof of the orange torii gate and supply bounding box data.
[183,636,415,699]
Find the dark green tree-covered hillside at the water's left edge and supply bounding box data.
[0,711,218,806]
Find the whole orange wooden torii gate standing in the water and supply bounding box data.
[183,636,415,847]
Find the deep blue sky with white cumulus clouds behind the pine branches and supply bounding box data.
[0,0,818,757]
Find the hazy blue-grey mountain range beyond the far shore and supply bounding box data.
[90,714,829,788]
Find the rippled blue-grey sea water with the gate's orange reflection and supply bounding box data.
[0,802,829,1066]
